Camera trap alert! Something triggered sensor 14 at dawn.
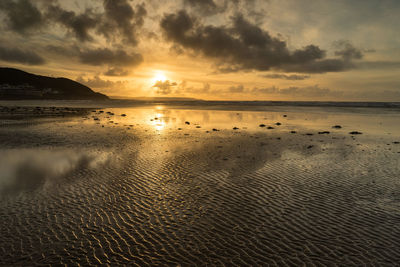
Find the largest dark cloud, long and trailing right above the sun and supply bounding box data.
[160,10,357,73]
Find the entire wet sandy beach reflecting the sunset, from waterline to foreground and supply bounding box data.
[0,107,400,266]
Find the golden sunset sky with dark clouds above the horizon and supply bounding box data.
[0,0,400,101]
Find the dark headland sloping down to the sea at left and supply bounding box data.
[0,68,109,100]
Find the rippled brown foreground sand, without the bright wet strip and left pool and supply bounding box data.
[0,113,400,266]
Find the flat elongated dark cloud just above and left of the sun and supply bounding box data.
[79,48,143,66]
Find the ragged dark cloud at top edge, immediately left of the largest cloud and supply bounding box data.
[98,0,147,45]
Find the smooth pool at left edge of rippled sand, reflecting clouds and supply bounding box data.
[0,149,110,196]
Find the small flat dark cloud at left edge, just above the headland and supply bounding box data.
[0,46,45,65]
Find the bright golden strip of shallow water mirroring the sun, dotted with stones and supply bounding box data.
[89,106,400,135]
